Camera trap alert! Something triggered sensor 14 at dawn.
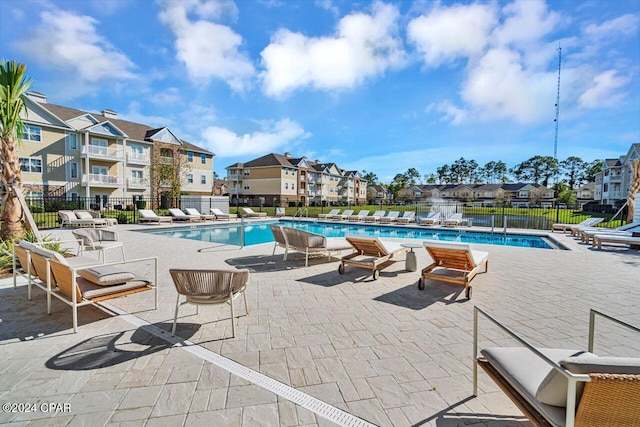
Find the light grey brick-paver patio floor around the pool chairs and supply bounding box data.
[0,225,640,426]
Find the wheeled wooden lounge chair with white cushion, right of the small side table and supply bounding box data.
[418,240,489,299]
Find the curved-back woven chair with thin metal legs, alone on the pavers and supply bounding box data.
[169,269,249,337]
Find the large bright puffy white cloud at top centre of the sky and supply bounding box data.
[261,3,405,98]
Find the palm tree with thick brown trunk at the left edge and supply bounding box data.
[0,59,31,240]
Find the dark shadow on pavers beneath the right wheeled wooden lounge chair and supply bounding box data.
[374,280,468,310]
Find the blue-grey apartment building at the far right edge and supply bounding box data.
[594,143,640,206]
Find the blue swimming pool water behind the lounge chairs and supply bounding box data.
[143,220,555,249]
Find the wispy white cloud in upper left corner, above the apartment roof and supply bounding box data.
[16,9,135,83]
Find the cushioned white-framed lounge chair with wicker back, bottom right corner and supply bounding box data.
[473,307,640,427]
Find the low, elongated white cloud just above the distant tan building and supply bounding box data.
[202,118,311,157]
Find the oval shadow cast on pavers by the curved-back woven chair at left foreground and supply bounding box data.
[45,323,200,371]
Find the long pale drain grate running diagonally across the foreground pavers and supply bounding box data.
[99,302,375,427]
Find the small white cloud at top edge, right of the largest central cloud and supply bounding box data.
[407,4,496,66]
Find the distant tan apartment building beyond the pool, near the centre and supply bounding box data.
[226,153,367,206]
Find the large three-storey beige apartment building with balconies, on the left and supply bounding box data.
[17,92,214,203]
